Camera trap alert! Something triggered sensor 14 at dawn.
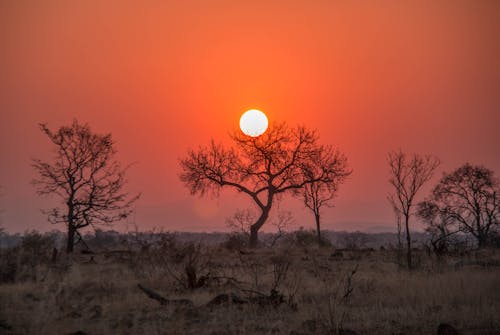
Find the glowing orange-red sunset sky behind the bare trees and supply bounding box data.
[0,0,500,231]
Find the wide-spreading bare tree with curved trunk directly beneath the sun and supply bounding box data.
[180,123,350,247]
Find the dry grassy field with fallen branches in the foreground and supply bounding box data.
[0,243,500,335]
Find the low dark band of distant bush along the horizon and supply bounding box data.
[0,228,475,252]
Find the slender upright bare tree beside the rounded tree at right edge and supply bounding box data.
[387,150,440,269]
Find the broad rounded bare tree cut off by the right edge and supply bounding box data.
[422,163,500,248]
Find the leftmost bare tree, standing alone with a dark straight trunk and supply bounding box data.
[32,120,139,253]
